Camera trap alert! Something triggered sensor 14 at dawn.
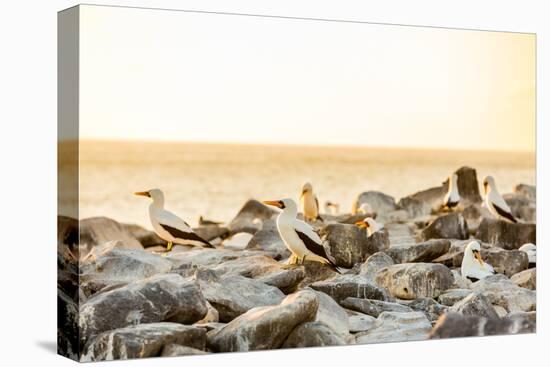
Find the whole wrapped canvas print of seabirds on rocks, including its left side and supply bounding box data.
[57,5,536,362]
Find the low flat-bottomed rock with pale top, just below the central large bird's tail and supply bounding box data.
[310,274,389,302]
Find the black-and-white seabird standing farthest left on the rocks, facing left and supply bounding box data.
[134,189,214,251]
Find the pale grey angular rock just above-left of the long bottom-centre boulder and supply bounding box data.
[197,273,284,322]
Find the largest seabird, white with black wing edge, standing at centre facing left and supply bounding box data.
[263,199,340,272]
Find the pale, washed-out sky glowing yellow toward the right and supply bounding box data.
[80,6,536,151]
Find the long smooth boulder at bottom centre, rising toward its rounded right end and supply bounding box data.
[207,290,319,352]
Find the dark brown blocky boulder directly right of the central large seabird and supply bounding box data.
[320,223,390,268]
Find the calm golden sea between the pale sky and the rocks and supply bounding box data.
[60,141,536,228]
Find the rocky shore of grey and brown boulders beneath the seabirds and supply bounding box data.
[58,167,536,361]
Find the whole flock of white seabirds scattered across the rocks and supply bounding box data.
[135,174,517,280]
